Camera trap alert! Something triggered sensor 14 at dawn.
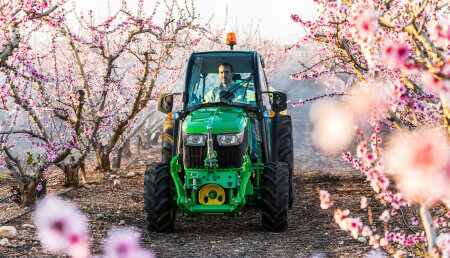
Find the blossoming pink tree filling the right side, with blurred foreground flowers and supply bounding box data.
[291,0,450,255]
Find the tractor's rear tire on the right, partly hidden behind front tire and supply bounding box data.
[278,115,294,208]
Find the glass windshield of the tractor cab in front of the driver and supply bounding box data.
[188,53,256,107]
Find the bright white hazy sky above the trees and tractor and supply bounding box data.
[75,0,317,44]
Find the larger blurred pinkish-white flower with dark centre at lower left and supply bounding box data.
[34,196,90,258]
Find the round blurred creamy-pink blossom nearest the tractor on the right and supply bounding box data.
[311,100,354,154]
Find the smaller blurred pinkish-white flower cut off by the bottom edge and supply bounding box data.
[103,228,155,258]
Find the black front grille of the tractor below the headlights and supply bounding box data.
[183,130,248,169]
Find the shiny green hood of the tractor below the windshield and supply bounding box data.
[183,107,247,134]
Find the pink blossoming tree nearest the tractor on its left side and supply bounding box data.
[47,1,204,170]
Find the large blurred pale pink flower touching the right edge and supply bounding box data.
[385,130,450,202]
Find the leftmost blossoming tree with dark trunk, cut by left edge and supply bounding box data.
[0,1,85,205]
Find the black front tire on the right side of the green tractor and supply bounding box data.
[261,162,289,232]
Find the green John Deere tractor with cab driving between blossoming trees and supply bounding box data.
[144,33,294,232]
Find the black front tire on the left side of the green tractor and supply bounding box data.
[144,163,176,232]
